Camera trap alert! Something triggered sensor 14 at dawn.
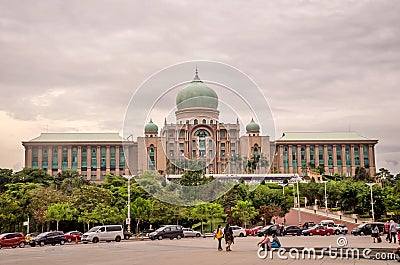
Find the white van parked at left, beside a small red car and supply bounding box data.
[81,225,124,244]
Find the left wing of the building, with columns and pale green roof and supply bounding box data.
[22,133,136,181]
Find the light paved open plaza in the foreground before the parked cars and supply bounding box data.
[0,236,397,265]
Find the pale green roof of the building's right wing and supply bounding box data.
[278,132,373,141]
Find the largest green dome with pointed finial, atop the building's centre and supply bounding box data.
[176,69,218,110]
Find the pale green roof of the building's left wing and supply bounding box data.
[28,133,122,143]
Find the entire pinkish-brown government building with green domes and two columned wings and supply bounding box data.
[22,69,378,181]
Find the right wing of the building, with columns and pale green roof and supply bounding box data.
[273,132,378,176]
